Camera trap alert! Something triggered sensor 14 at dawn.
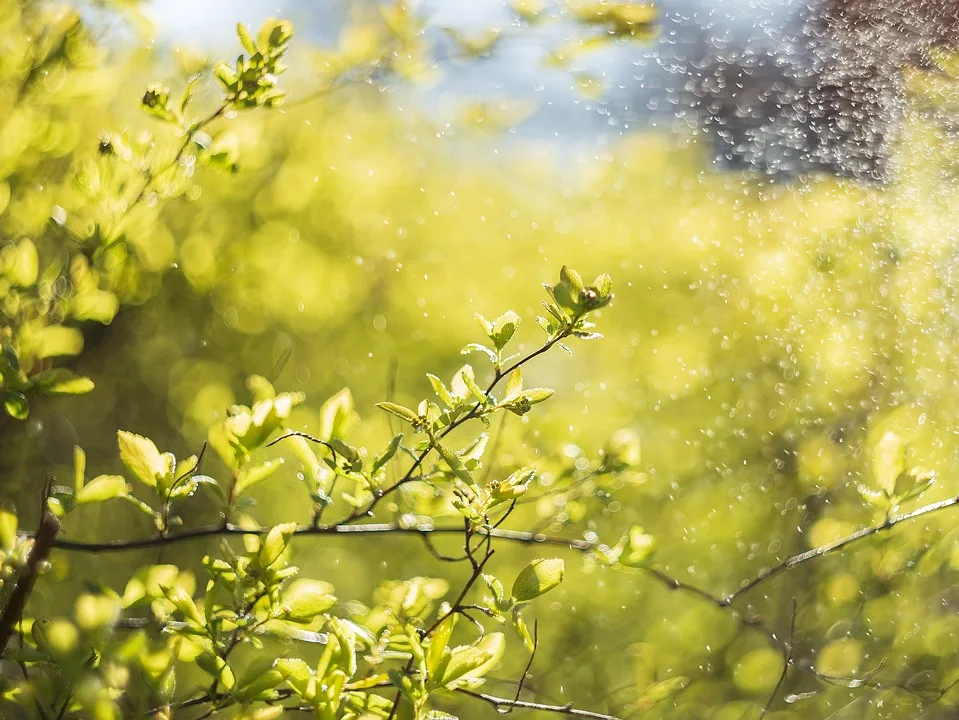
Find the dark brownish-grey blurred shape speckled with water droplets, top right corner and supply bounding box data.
[686,0,959,182]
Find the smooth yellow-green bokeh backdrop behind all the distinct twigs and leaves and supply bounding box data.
[0,1,959,720]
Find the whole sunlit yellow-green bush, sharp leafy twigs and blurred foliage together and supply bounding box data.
[0,2,957,718]
